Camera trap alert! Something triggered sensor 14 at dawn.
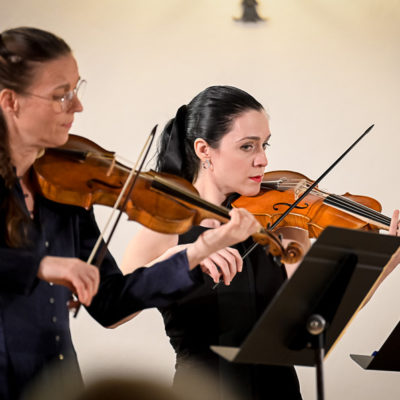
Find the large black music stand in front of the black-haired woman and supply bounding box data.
[211,227,400,400]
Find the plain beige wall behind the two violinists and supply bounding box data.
[0,0,400,400]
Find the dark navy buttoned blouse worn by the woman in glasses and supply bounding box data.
[0,180,202,400]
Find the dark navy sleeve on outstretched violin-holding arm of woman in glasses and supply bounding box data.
[79,211,203,326]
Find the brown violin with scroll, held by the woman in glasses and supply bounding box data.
[33,135,302,263]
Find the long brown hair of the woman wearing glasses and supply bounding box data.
[0,27,71,247]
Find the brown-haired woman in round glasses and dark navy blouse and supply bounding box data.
[0,28,258,400]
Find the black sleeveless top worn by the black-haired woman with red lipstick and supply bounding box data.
[160,227,301,400]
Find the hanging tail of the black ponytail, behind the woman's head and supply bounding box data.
[161,105,187,175]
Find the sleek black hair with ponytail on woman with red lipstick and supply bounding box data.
[156,86,263,182]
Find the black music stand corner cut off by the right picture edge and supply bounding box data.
[350,322,400,371]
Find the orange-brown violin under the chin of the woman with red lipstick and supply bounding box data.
[232,171,390,238]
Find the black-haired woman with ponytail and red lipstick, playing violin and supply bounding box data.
[122,86,400,400]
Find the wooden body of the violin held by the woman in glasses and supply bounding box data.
[34,135,208,234]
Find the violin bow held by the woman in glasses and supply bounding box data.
[74,125,158,318]
